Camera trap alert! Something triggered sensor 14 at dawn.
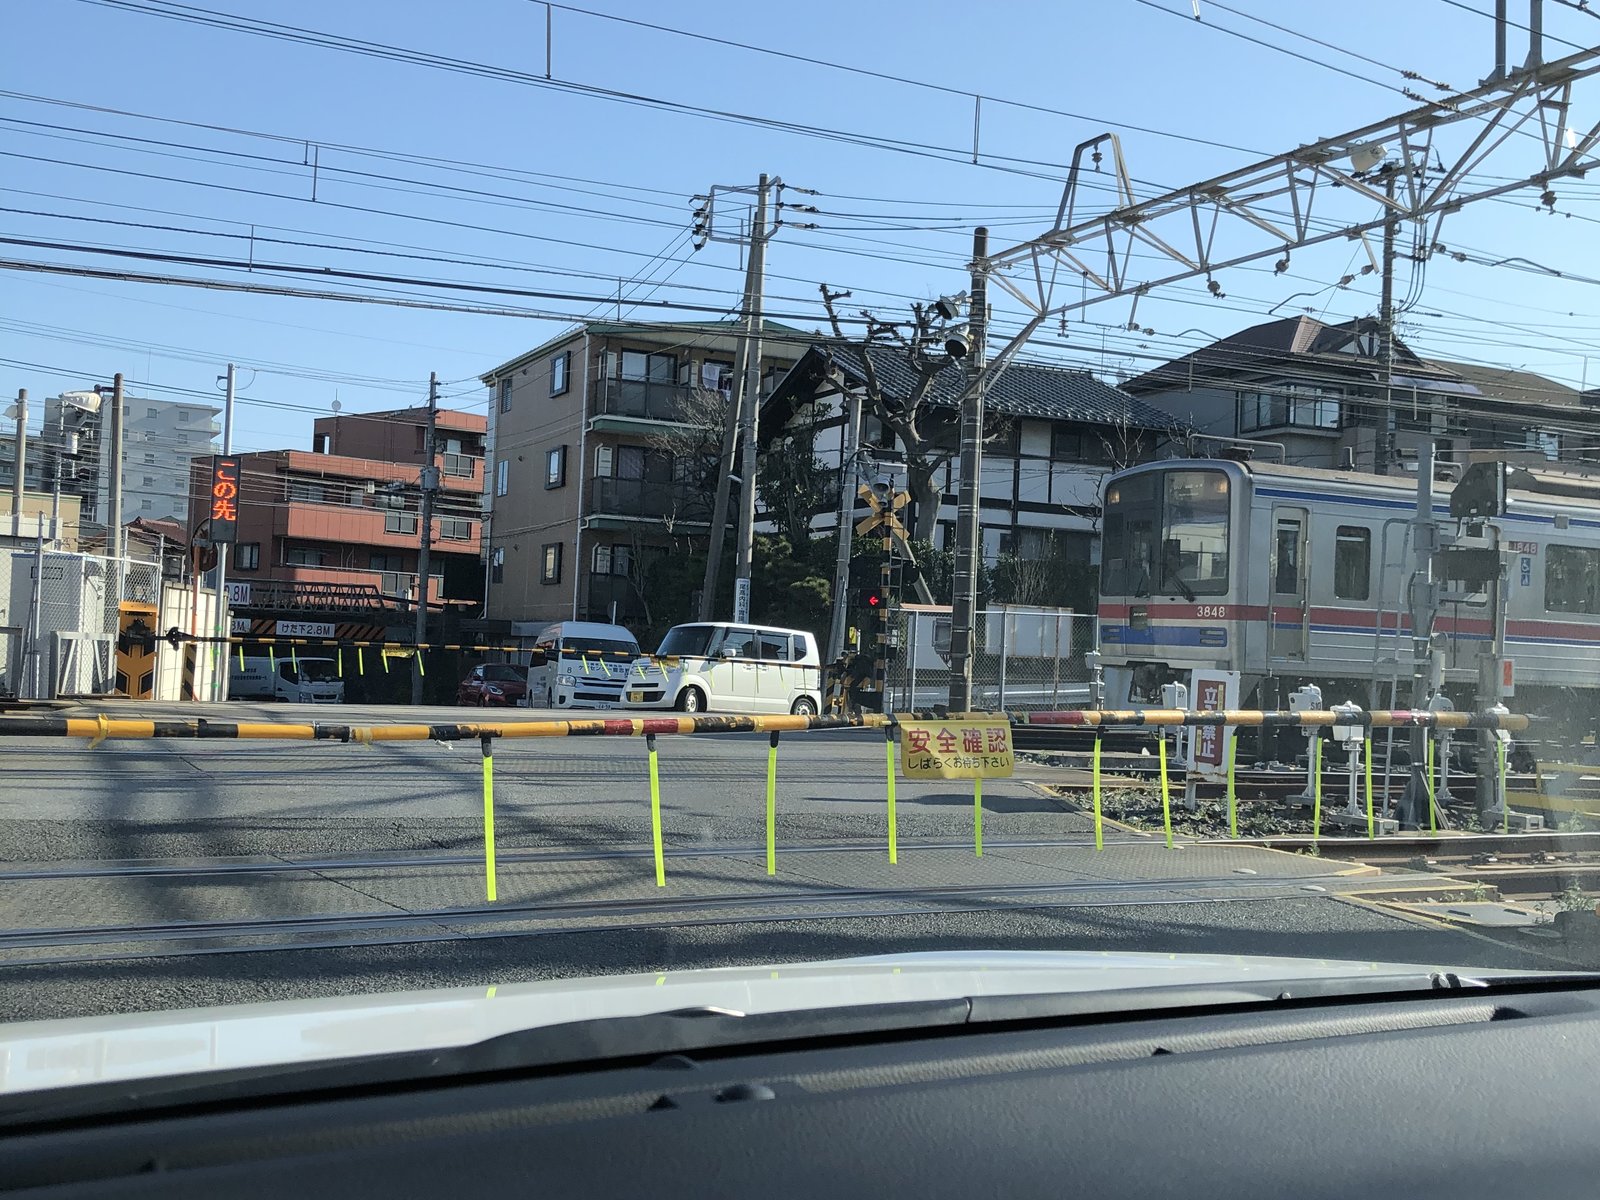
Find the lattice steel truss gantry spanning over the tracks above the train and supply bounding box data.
[950,37,1600,723]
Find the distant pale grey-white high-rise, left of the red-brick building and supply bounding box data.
[40,390,222,525]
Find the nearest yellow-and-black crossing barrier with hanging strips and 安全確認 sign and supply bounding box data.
[0,709,1530,902]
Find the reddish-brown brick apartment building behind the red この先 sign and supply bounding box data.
[190,408,488,603]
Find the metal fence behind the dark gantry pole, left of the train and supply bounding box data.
[886,606,1099,712]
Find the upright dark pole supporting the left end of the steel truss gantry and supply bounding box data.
[950,226,989,712]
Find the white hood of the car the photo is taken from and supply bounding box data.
[0,952,1523,1094]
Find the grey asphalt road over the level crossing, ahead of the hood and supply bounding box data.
[0,704,1570,1019]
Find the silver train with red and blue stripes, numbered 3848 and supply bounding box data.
[1099,459,1600,738]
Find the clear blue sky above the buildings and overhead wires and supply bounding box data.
[0,0,1600,450]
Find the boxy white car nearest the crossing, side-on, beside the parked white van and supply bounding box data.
[627,622,822,715]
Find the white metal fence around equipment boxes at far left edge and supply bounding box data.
[0,549,162,699]
